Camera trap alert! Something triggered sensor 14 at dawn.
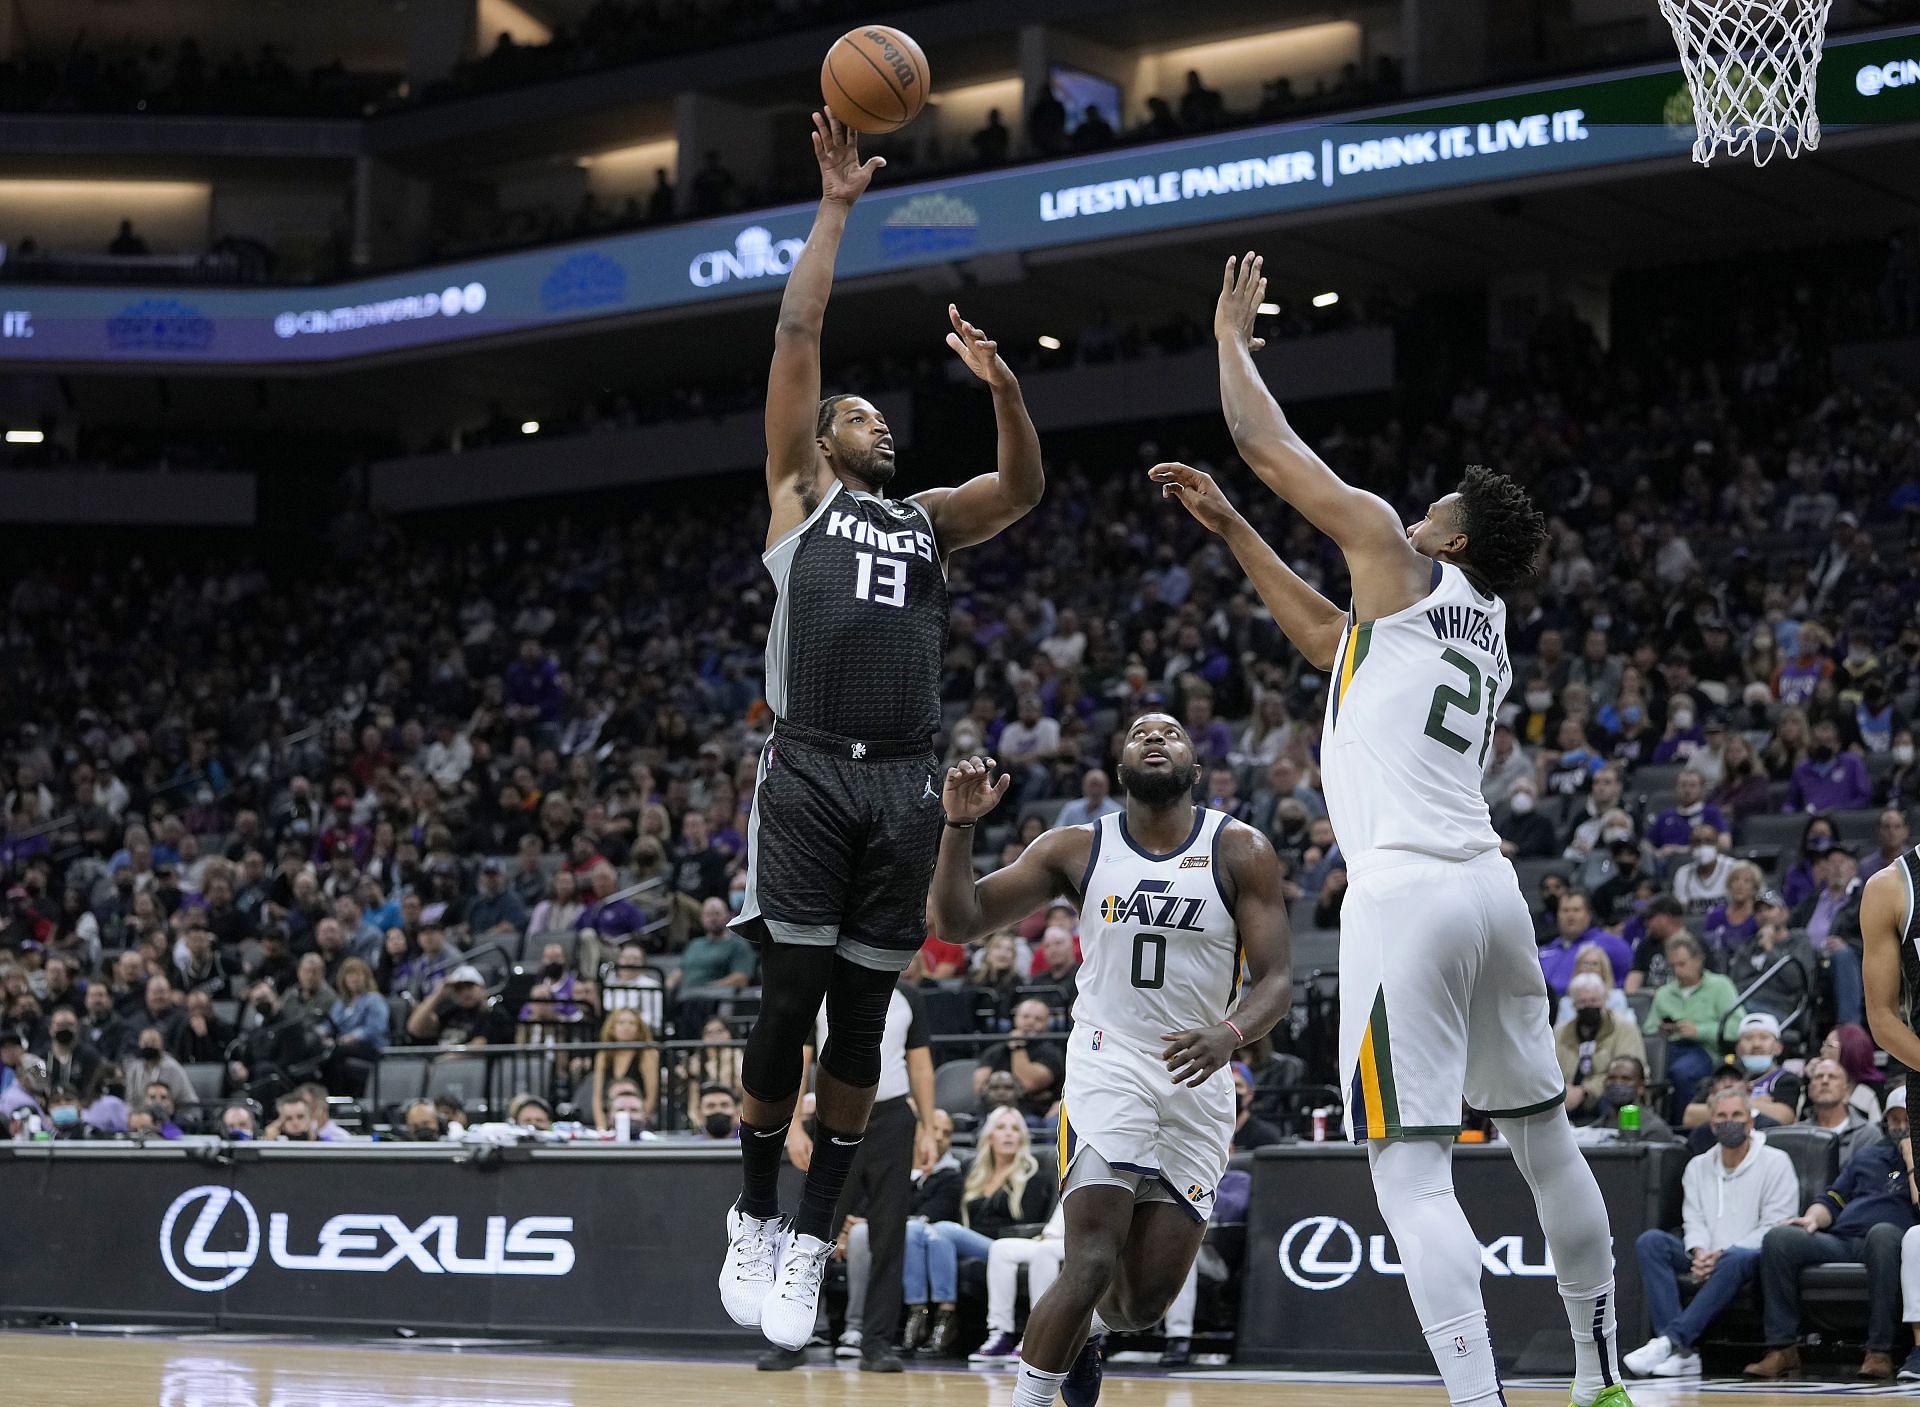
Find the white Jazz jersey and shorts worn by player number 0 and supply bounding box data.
[1060,808,1242,1221]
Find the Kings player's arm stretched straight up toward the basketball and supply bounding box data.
[766,111,887,541]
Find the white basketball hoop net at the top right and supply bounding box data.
[1659,0,1834,167]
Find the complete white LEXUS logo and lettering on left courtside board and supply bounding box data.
[159,1186,574,1292]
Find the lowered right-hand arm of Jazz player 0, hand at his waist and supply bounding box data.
[1162,822,1294,1086]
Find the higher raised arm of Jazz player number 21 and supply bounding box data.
[1213,251,1432,620]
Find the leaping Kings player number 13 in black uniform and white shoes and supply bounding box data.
[720,113,1044,1367]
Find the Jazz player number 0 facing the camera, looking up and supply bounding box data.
[929,714,1294,1407]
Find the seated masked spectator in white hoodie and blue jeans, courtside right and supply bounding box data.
[1620,1085,1799,1378]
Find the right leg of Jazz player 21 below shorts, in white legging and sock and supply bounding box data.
[1498,1109,1620,1407]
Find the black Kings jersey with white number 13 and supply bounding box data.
[762,480,947,743]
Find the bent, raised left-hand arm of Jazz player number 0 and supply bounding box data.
[927,758,1092,942]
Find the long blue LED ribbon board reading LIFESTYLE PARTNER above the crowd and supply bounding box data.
[0,31,1920,365]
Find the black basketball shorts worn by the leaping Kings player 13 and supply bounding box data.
[732,724,945,971]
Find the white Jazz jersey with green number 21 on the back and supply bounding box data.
[1321,562,1513,877]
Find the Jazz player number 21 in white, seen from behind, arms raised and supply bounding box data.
[1148,253,1628,1407]
